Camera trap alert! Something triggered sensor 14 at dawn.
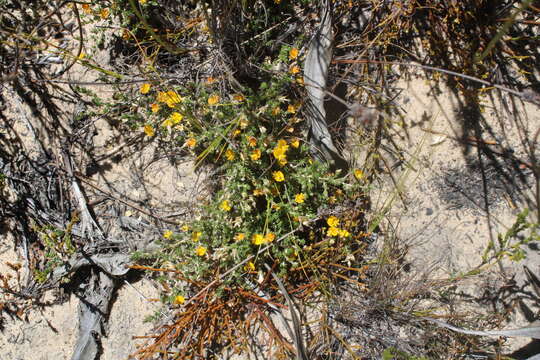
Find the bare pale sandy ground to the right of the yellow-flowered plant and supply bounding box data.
[372,76,540,355]
